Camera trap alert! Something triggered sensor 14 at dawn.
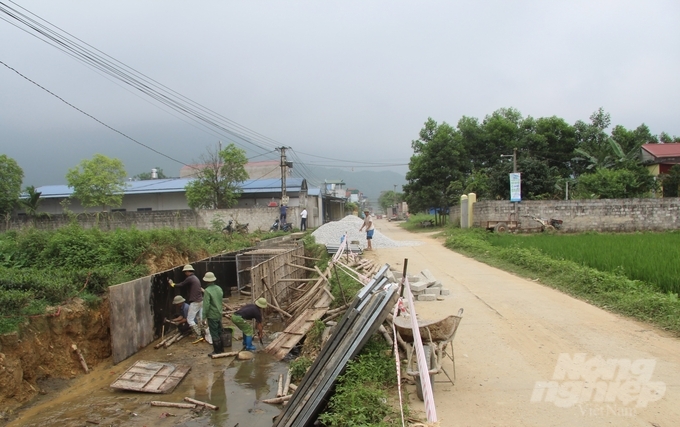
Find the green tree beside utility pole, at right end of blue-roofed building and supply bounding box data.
[186,144,248,209]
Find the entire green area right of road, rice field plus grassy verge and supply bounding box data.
[446,228,680,333]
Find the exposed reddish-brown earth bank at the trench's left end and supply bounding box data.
[0,298,111,419]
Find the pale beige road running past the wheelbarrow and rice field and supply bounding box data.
[367,220,680,427]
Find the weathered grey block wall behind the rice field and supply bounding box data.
[473,198,680,232]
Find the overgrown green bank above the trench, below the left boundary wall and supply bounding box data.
[0,224,251,334]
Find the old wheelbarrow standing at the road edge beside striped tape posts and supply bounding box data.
[394,308,463,400]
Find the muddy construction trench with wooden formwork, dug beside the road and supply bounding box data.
[2,234,404,426]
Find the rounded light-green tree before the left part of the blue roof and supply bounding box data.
[66,154,127,210]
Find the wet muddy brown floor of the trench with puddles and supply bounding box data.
[9,325,288,427]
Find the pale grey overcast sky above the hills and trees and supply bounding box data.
[0,0,680,186]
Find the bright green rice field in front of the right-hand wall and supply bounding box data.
[489,232,680,294]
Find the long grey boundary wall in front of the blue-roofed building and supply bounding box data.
[1,206,314,231]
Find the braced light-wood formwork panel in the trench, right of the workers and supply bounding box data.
[244,245,306,310]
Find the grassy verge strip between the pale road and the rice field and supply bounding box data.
[445,228,680,334]
